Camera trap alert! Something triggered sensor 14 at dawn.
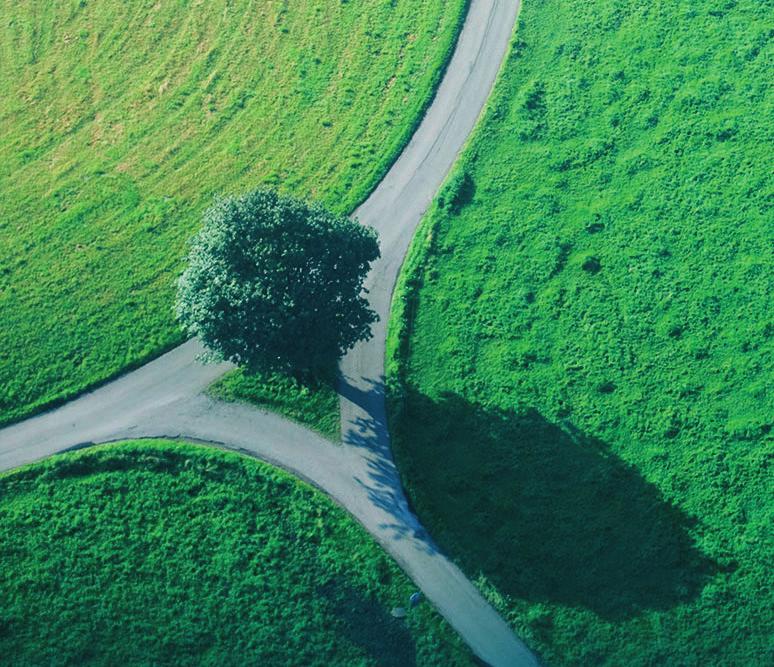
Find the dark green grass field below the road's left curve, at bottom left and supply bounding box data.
[0,441,472,667]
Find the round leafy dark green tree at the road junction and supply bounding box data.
[175,189,379,378]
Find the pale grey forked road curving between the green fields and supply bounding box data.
[0,0,537,665]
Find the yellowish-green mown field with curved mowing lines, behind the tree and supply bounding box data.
[0,0,466,423]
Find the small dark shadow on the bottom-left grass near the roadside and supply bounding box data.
[318,580,416,667]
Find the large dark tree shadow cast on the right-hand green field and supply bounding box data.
[391,391,717,619]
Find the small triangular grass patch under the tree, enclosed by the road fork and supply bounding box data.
[208,369,341,441]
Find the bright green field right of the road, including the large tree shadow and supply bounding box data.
[389,0,774,666]
